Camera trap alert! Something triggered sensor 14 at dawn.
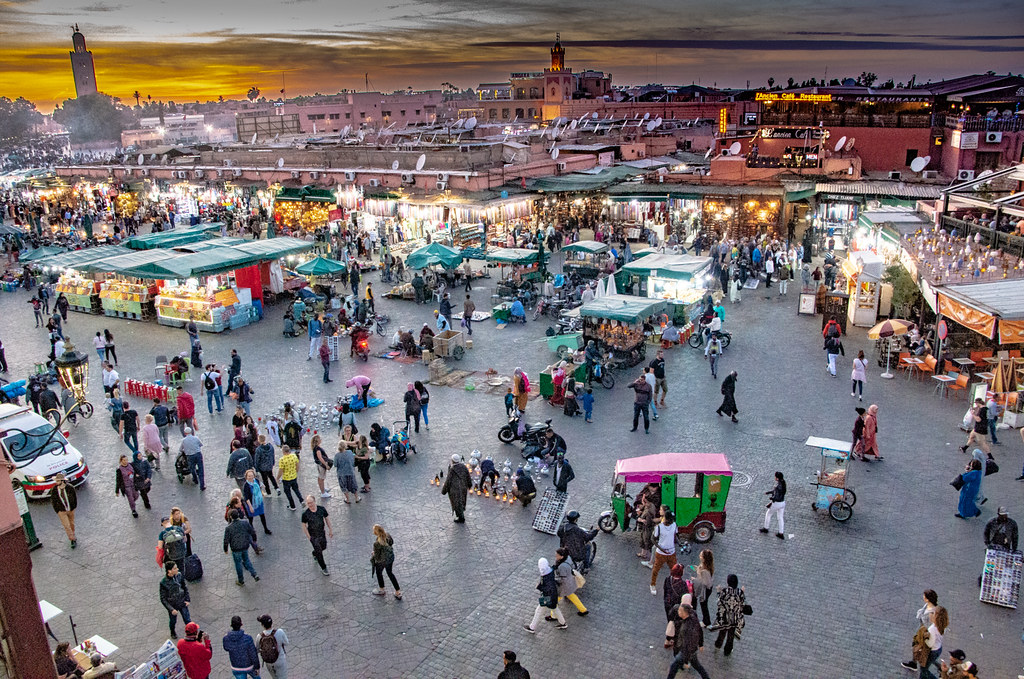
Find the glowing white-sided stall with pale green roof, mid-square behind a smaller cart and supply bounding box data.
[615,253,712,327]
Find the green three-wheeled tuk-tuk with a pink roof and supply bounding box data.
[598,453,732,543]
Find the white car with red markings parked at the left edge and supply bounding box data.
[0,404,89,499]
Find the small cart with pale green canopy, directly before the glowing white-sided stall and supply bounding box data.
[580,295,667,367]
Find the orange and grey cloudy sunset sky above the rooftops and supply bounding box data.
[0,0,1024,112]
